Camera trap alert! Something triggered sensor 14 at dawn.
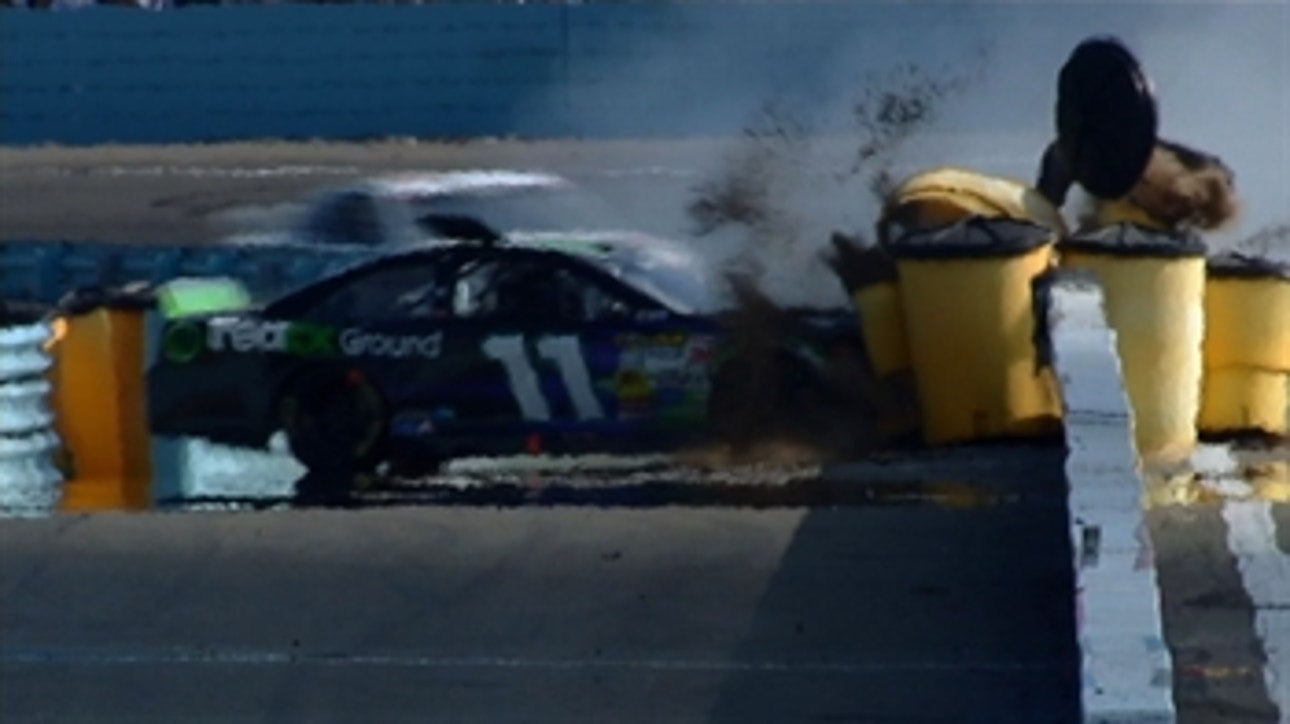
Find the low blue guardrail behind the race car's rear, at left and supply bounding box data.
[0,241,377,305]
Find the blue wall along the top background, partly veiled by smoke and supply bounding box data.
[0,3,1287,145]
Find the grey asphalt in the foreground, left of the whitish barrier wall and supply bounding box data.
[0,490,1077,723]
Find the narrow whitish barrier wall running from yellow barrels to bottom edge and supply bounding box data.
[1049,281,1174,721]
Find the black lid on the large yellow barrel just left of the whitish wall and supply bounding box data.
[888,217,1055,259]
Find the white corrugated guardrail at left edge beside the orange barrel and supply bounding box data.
[0,321,63,514]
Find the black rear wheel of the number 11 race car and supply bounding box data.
[277,368,386,497]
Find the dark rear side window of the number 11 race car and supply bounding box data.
[307,265,449,321]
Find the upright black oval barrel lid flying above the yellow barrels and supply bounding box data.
[1055,36,1158,199]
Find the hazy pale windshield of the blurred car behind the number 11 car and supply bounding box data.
[414,186,623,234]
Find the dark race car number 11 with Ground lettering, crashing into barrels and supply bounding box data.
[147,234,860,493]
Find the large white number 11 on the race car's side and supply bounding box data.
[482,334,605,419]
